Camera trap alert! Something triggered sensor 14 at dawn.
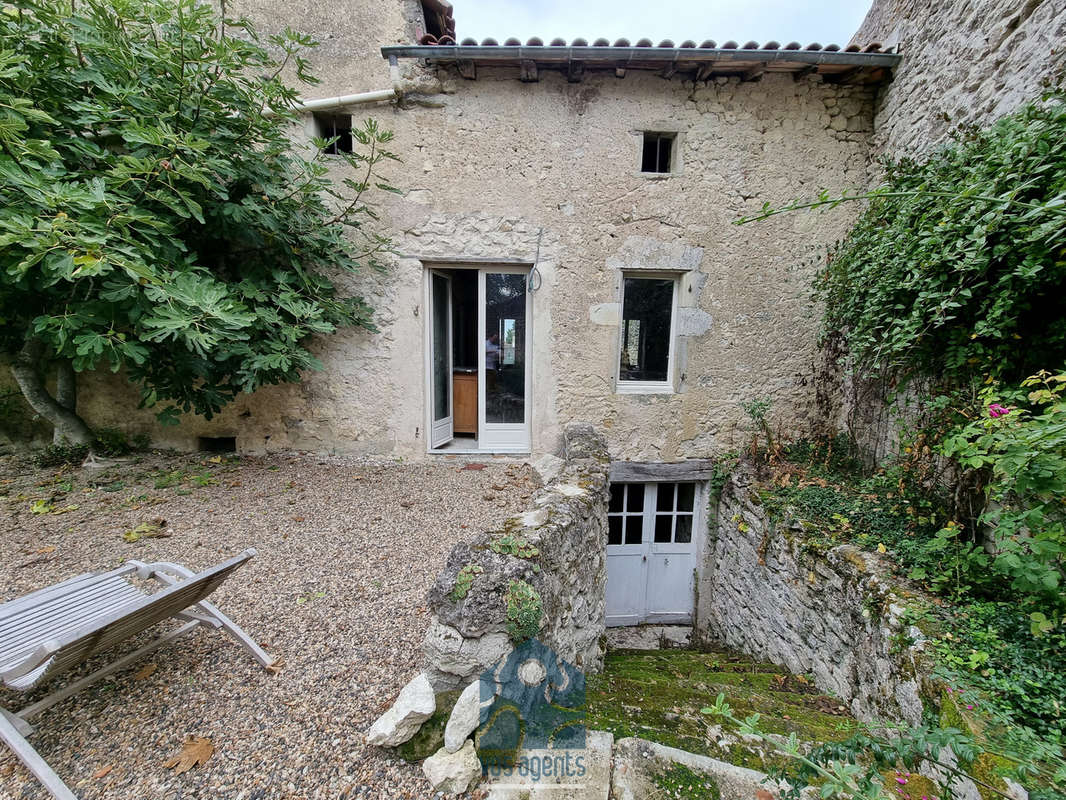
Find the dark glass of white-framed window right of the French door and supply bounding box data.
[618,277,674,383]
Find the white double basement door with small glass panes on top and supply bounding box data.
[607,482,698,627]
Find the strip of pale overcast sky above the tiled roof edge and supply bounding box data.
[451,0,870,46]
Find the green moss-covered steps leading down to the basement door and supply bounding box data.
[586,651,854,771]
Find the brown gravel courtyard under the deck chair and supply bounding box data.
[0,453,537,800]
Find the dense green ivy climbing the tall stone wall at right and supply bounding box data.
[805,92,1066,381]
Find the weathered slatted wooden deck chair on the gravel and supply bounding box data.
[0,549,274,800]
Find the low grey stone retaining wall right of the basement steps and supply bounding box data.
[698,469,922,724]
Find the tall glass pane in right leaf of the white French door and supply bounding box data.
[484,272,526,425]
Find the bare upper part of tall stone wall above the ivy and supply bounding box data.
[852,0,1066,156]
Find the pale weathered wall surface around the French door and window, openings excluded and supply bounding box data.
[73,0,873,461]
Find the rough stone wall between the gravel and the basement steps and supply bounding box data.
[424,425,610,691]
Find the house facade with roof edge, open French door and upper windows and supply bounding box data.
[82,0,899,462]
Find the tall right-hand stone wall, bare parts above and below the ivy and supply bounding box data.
[823,0,1066,462]
